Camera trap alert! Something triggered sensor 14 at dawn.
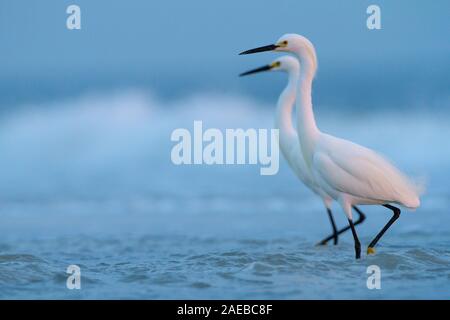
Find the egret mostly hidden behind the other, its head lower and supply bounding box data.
[240,56,365,244]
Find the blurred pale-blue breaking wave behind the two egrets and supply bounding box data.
[0,90,450,199]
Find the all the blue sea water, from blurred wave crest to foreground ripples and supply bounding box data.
[0,90,450,299]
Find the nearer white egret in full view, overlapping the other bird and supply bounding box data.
[241,34,421,259]
